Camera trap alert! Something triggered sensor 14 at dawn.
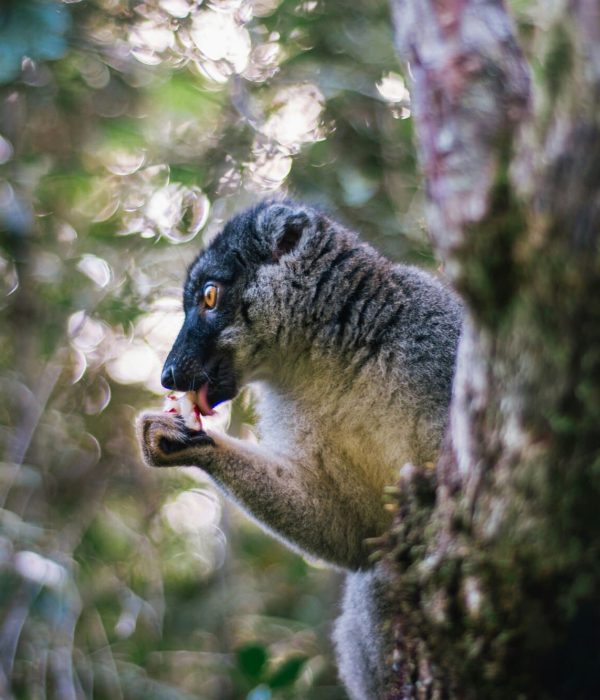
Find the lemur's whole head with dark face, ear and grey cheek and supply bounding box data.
[161,200,336,414]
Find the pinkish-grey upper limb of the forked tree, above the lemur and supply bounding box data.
[392,0,529,277]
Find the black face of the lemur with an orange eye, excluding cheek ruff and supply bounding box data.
[161,204,306,415]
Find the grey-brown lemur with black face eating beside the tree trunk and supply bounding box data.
[139,200,461,700]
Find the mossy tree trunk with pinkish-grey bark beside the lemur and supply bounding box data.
[382,0,600,699]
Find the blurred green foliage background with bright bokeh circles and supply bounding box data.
[0,0,435,700]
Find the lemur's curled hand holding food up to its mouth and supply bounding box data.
[137,413,216,467]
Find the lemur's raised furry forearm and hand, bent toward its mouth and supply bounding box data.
[138,413,379,569]
